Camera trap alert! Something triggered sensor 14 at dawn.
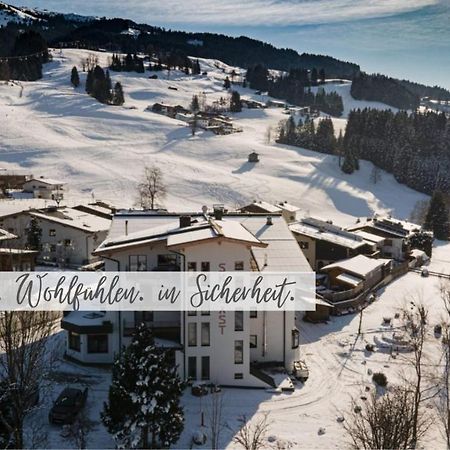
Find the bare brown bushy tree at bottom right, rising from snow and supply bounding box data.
[344,386,429,450]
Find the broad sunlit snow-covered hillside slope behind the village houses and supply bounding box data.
[0,50,424,223]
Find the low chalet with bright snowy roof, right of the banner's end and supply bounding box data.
[321,255,392,291]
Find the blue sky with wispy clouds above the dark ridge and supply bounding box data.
[10,0,450,88]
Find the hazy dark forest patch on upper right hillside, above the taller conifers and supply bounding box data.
[350,72,420,110]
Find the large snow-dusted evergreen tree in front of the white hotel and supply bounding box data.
[101,325,184,448]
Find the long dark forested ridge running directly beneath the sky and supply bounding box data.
[39,16,359,78]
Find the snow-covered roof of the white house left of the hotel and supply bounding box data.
[30,208,111,233]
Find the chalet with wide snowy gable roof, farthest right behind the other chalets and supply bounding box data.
[348,217,421,261]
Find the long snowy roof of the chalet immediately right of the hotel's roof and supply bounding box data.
[289,217,367,249]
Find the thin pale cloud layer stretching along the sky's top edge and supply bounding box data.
[11,0,440,26]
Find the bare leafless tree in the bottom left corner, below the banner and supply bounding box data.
[0,311,59,448]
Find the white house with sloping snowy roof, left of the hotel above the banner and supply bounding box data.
[29,207,111,268]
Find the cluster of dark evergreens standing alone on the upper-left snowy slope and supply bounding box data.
[83,65,125,105]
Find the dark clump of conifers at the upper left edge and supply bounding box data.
[0,30,50,81]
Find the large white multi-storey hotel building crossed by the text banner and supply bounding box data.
[62,211,311,387]
